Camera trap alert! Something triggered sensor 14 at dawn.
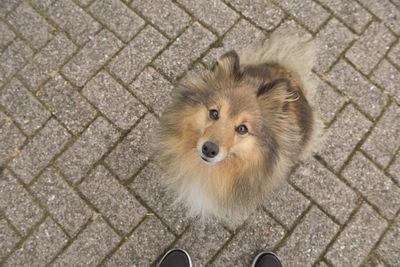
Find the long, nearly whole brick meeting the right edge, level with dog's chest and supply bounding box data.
[343,152,400,219]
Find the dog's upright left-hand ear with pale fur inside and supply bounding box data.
[211,50,242,80]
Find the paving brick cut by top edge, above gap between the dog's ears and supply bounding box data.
[229,0,285,31]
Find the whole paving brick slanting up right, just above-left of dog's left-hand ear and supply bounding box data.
[154,22,215,79]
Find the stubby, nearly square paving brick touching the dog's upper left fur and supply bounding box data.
[129,67,174,116]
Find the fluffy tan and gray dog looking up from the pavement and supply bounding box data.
[155,31,322,224]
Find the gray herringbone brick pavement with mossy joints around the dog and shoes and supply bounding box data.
[0,0,400,266]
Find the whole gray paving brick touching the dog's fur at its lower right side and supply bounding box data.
[290,159,358,224]
